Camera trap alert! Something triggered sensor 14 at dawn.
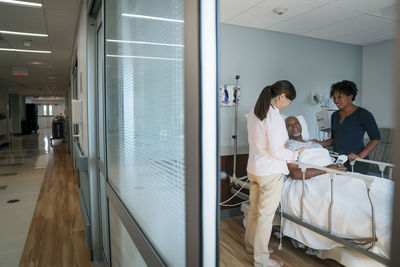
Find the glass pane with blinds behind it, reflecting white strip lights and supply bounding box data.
[105,0,185,266]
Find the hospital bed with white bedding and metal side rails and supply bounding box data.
[229,115,394,266]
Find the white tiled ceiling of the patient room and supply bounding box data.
[220,0,397,46]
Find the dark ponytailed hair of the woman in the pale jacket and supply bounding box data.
[254,80,296,121]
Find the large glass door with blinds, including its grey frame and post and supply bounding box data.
[103,0,217,266]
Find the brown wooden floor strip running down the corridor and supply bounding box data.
[19,144,93,267]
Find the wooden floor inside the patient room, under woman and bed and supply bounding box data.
[219,216,342,267]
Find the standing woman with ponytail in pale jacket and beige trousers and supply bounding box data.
[245,80,304,267]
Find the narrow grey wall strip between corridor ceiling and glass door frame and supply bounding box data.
[71,4,89,155]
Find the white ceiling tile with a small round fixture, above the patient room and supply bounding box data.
[227,0,323,29]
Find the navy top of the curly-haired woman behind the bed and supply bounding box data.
[331,107,381,158]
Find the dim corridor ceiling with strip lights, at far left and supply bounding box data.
[0,0,81,96]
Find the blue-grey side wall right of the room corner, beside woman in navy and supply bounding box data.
[361,41,396,128]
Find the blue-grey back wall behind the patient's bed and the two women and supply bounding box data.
[218,24,362,150]
